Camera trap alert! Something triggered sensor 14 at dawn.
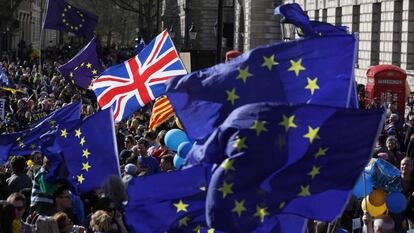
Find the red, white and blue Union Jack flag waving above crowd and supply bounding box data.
[92,31,187,122]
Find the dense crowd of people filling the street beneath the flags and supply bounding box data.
[0,45,414,233]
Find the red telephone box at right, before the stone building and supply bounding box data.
[366,65,407,116]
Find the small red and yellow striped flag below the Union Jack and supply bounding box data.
[148,96,174,130]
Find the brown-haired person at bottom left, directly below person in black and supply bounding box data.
[7,193,34,233]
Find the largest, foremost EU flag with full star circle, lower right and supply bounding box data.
[188,103,384,232]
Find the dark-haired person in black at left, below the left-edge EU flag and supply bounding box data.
[7,156,32,192]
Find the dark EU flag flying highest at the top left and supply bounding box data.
[43,0,98,39]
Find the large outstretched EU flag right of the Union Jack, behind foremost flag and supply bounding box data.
[166,32,356,139]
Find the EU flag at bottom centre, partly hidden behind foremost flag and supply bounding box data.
[125,166,217,233]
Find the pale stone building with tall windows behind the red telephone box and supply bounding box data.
[235,0,414,90]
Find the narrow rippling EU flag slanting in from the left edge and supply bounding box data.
[0,102,81,162]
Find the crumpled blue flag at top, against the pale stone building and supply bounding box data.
[274,3,347,37]
